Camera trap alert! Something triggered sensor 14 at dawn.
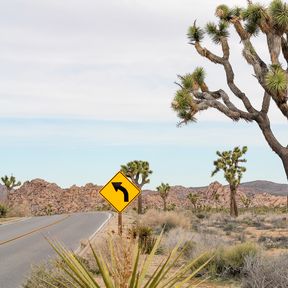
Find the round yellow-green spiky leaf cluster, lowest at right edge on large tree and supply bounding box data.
[265,65,288,94]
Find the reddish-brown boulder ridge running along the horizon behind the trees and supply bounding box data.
[9,179,286,215]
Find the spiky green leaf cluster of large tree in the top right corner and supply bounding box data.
[269,0,288,31]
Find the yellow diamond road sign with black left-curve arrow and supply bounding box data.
[100,172,141,212]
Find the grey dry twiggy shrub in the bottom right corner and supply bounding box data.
[242,254,288,288]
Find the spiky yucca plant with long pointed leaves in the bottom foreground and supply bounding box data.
[43,232,213,288]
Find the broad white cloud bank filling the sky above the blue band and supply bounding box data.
[0,0,285,123]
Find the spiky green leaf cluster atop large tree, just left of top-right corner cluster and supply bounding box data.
[242,4,264,35]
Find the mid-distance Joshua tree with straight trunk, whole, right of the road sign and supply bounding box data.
[212,146,248,217]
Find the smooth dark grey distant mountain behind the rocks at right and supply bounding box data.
[241,180,288,196]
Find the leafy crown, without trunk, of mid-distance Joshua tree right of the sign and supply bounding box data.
[212,146,248,187]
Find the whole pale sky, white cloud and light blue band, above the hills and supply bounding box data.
[0,0,288,188]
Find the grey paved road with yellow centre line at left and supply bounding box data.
[0,212,110,288]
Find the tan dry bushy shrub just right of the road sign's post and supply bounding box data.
[139,210,191,233]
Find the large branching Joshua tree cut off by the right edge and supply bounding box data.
[172,0,288,184]
